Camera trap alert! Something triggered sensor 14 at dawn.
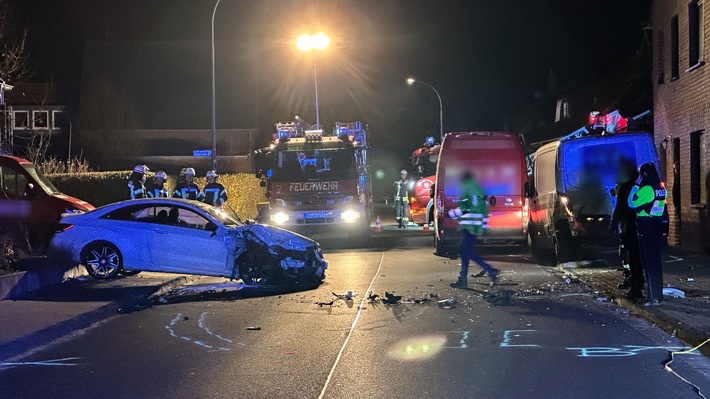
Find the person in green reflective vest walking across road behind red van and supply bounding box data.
[449,172,499,288]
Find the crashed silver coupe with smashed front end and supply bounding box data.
[50,198,328,285]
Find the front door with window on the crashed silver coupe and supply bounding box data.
[148,206,231,276]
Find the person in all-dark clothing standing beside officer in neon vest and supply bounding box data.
[609,158,643,300]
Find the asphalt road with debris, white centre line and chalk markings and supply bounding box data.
[0,230,710,398]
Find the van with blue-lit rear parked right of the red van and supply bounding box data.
[526,132,662,263]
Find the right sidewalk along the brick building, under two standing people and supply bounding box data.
[558,247,710,357]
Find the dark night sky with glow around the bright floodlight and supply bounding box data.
[11,0,650,166]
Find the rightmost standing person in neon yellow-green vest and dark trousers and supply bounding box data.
[628,162,666,306]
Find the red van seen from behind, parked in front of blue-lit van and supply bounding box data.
[434,132,528,256]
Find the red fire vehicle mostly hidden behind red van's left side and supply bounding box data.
[409,137,441,226]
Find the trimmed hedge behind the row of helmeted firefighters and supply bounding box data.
[47,171,266,219]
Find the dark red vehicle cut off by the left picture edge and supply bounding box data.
[0,155,94,248]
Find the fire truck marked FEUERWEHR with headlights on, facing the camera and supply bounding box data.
[253,121,372,237]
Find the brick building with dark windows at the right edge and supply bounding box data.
[651,0,710,252]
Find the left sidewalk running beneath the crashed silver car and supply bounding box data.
[0,265,189,368]
